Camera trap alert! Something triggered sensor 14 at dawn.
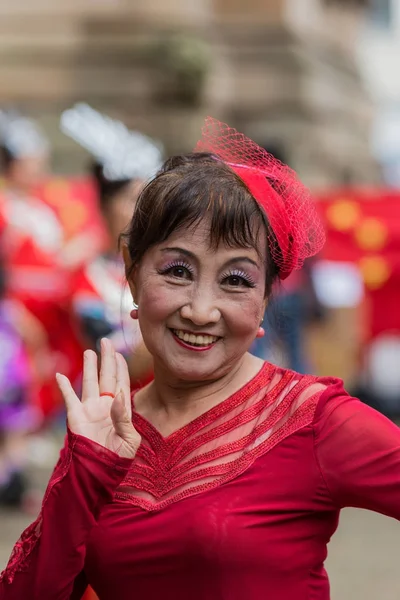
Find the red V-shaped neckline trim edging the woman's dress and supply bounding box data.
[131,362,277,446]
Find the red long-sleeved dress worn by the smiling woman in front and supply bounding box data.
[0,363,400,600]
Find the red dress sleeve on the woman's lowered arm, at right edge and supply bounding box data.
[314,381,400,520]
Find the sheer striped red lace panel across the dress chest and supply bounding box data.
[115,364,325,511]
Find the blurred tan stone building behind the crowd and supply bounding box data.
[0,0,379,185]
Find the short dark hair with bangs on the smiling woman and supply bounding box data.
[121,153,278,296]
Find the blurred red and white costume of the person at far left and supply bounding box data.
[0,190,82,414]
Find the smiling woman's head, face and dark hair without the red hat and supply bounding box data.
[123,153,278,389]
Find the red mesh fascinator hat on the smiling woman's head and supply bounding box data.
[195,117,325,279]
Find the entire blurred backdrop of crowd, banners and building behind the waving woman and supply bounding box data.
[0,0,400,600]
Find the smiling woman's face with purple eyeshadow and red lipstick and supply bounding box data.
[131,221,267,382]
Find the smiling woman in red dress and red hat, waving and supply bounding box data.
[0,120,400,600]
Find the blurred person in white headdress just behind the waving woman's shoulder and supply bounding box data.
[60,103,162,386]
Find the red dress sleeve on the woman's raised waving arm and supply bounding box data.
[0,431,132,600]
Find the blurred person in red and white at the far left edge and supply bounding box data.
[0,111,82,416]
